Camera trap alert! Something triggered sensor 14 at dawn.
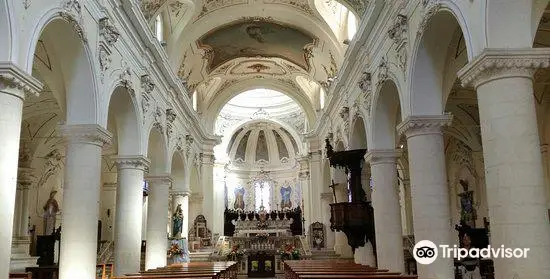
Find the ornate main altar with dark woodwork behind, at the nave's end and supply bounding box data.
[215,206,311,278]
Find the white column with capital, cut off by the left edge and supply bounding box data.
[0,62,42,279]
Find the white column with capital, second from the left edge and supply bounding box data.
[59,124,112,279]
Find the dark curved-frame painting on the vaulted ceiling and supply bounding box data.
[197,20,316,71]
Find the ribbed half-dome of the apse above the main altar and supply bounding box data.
[227,121,299,166]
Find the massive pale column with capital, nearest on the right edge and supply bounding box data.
[459,48,550,279]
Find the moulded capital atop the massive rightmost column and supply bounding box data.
[458,48,550,88]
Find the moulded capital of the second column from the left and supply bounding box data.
[59,124,113,146]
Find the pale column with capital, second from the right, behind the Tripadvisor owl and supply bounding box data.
[397,115,456,279]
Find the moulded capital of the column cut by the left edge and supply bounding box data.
[0,62,42,99]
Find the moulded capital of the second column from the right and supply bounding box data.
[397,113,453,138]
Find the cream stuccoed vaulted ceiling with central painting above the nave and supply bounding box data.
[141,0,364,127]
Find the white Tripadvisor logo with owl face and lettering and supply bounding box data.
[413,240,530,265]
